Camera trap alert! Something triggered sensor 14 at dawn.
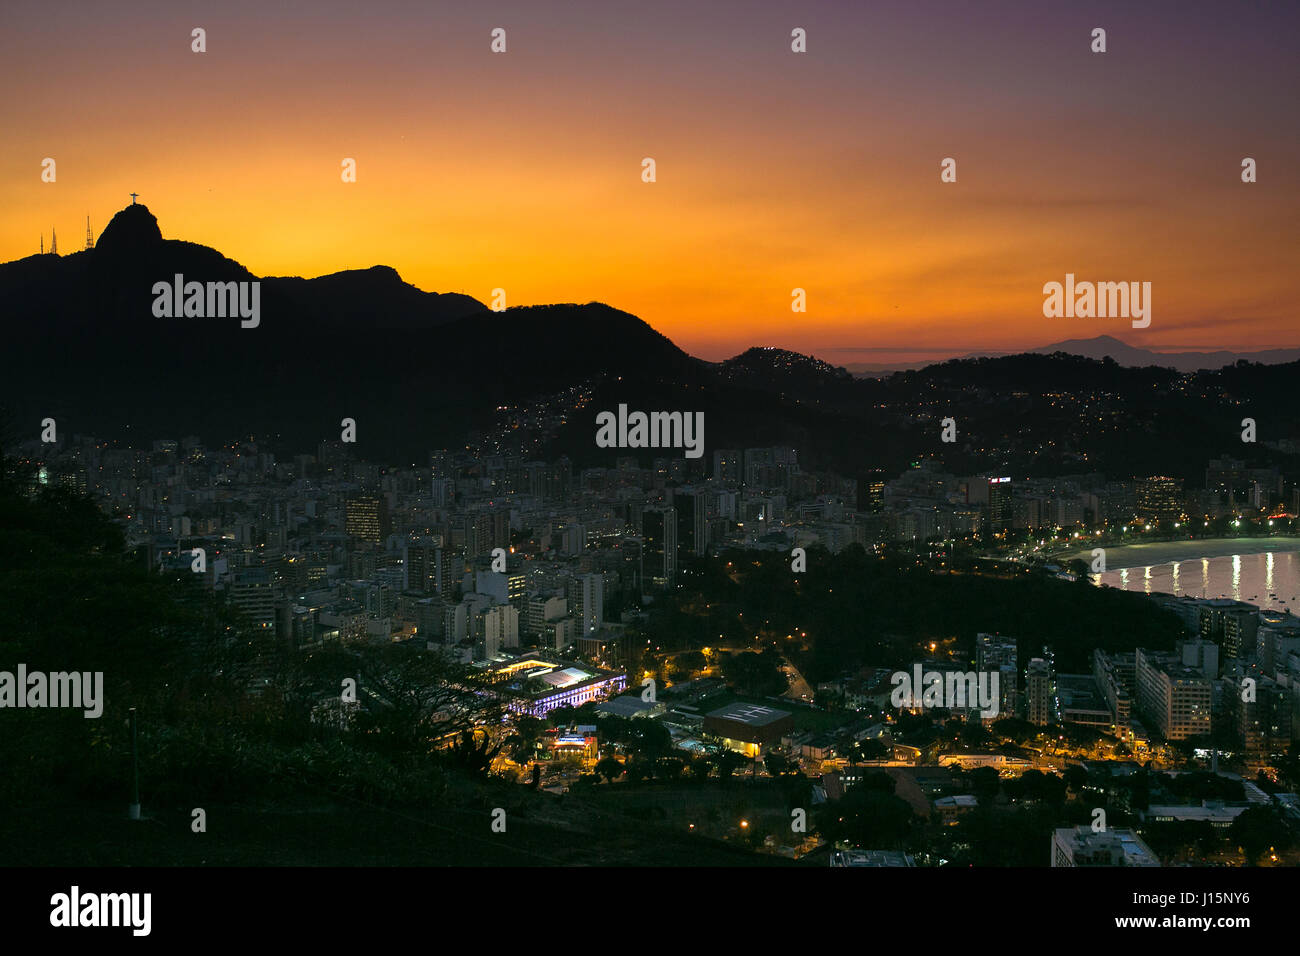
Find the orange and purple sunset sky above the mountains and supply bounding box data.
[0,0,1300,364]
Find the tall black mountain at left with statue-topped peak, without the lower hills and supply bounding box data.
[0,204,707,460]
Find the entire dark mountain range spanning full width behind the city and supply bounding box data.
[0,206,1300,481]
